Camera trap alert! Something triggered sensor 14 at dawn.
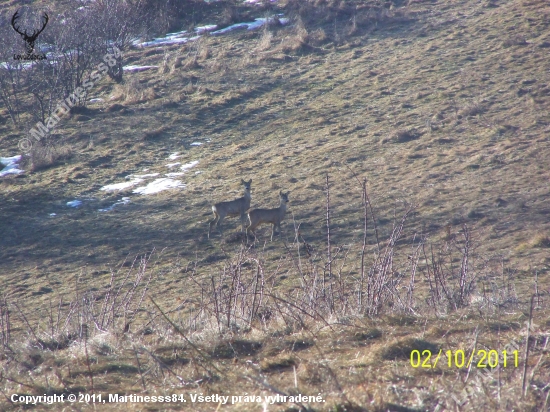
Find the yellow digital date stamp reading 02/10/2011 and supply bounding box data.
[411,349,519,369]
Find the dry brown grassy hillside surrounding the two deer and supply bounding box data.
[0,0,550,411]
